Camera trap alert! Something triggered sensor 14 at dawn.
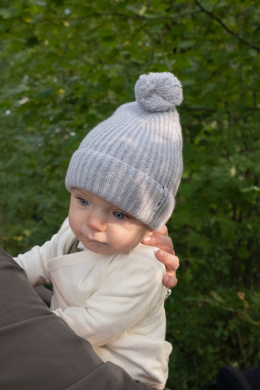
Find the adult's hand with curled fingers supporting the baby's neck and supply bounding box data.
[142,225,179,288]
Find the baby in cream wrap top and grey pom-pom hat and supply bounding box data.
[16,72,183,390]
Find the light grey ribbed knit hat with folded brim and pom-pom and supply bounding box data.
[66,72,183,230]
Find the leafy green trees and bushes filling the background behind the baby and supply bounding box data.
[0,0,260,390]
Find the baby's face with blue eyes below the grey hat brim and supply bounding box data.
[69,188,151,255]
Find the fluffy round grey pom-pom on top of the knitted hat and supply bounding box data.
[135,72,183,112]
